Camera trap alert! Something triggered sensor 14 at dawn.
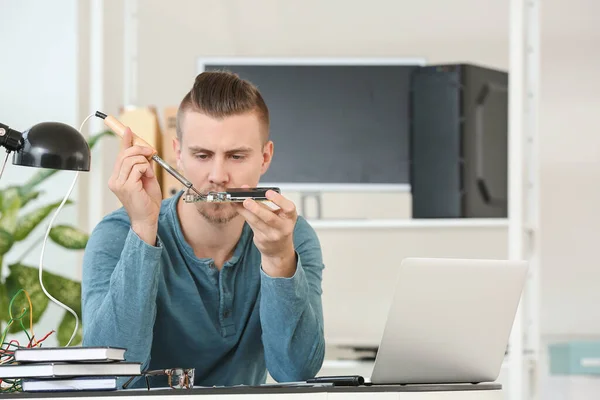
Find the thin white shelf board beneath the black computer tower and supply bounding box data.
[308,218,508,229]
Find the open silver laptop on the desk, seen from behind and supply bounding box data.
[370,258,527,385]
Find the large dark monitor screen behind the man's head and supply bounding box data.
[199,60,418,185]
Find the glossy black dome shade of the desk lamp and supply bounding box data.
[13,122,91,171]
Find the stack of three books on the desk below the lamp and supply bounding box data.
[0,347,141,392]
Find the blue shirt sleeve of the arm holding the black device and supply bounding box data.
[260,217,325,382]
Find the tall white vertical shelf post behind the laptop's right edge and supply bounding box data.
[508,0,540,400]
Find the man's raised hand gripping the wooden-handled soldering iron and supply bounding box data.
[108,128,162,246]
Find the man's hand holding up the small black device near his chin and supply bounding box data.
[238,186,298,278]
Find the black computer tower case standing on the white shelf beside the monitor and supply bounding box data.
[410,64,508,218]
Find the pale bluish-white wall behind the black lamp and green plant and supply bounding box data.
[0,0,81,345]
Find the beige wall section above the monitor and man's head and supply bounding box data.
[138,0,508,120]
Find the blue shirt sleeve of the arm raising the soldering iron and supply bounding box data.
[81,212,162,376]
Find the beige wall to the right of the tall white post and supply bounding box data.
[540,22,600,337]
